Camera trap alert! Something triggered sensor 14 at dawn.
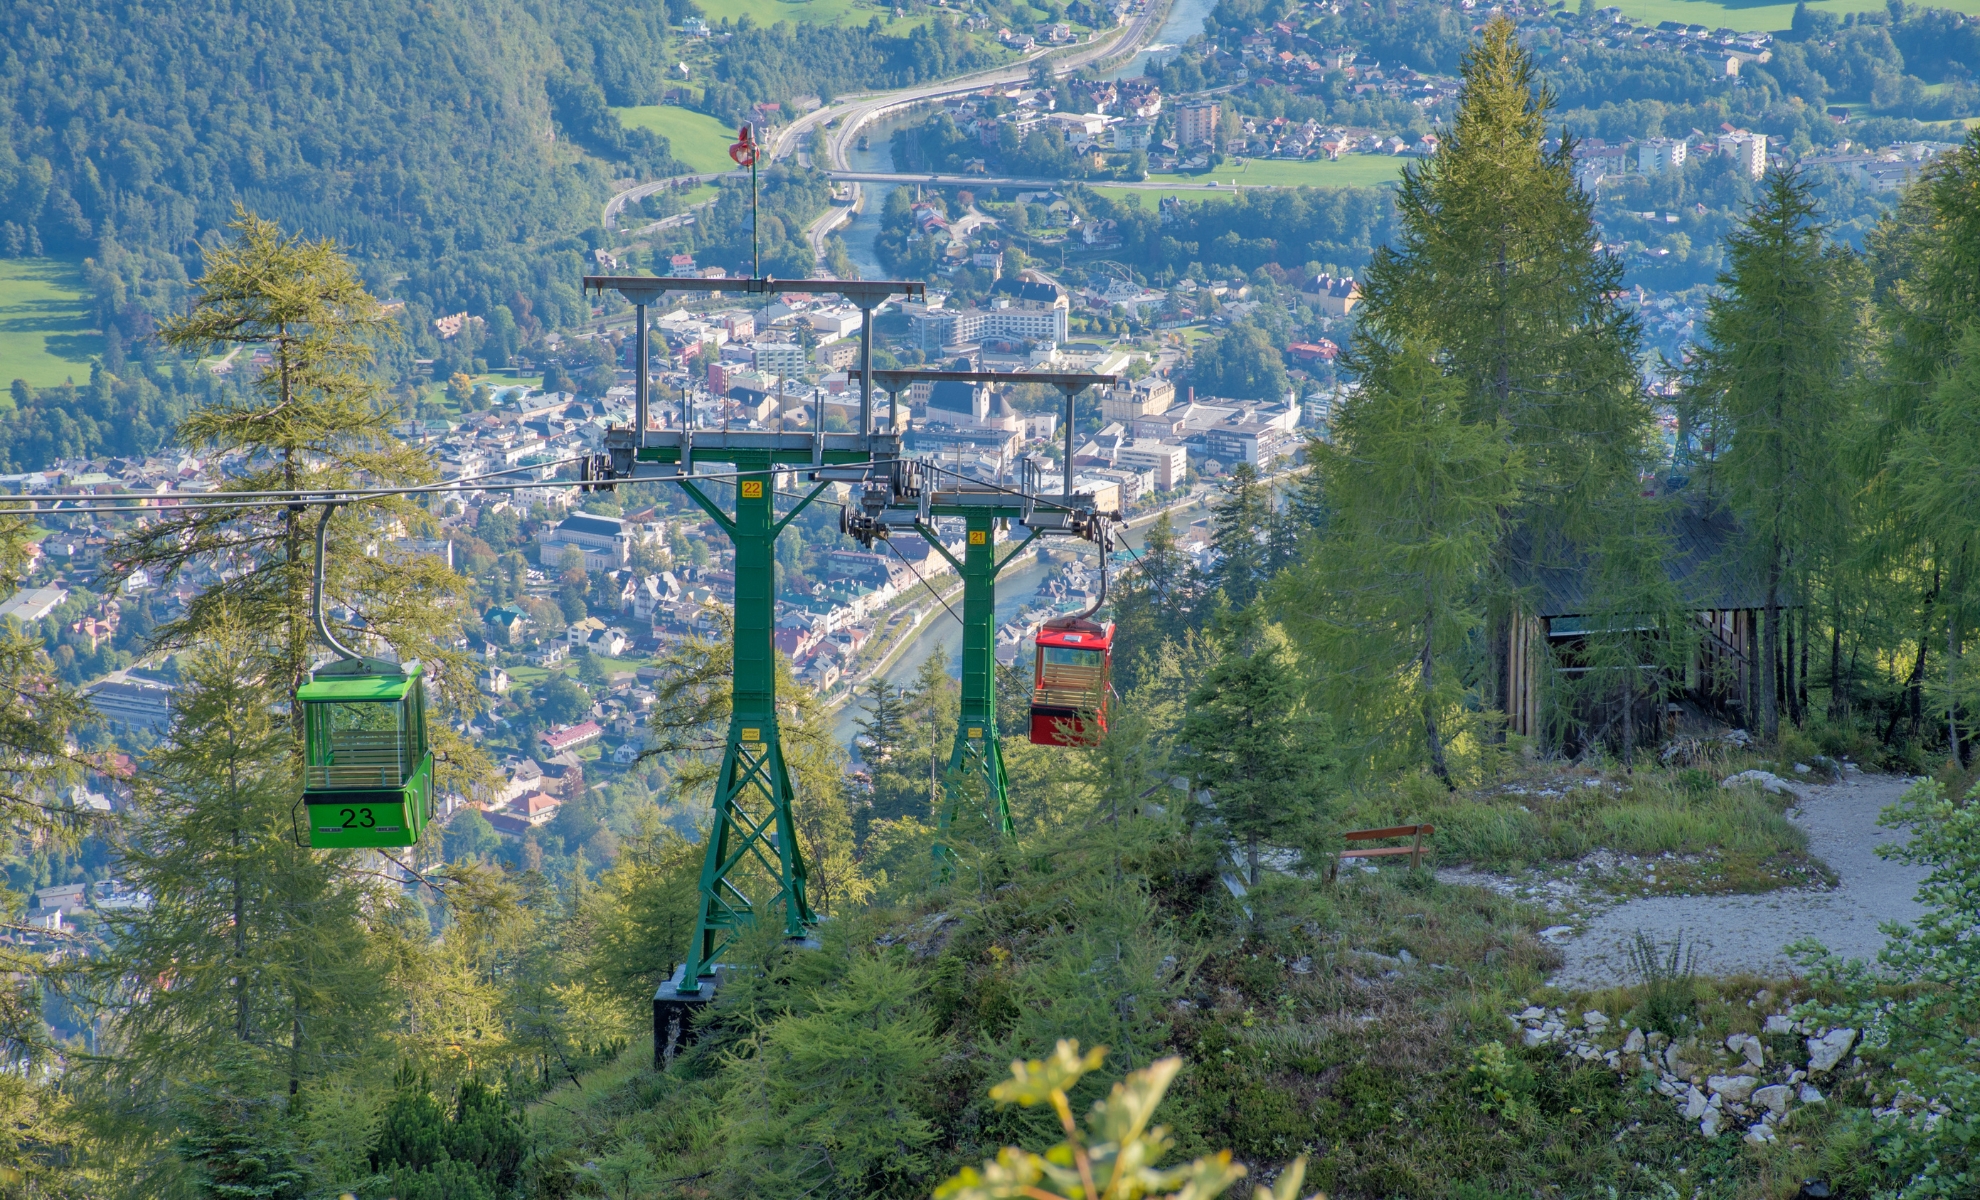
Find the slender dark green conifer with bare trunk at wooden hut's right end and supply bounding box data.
[1689,170,1863,739]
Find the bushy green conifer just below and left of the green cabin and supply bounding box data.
[95,640,398,1109]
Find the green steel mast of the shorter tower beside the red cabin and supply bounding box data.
[917,505,1038,869]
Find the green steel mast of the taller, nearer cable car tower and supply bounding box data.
[679,450,818,996]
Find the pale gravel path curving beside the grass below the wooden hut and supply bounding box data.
[1548,774,1925,988]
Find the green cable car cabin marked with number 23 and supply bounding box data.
[295,659,434,850]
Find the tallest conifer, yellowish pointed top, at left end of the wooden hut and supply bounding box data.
[1346,16,1649,728]
